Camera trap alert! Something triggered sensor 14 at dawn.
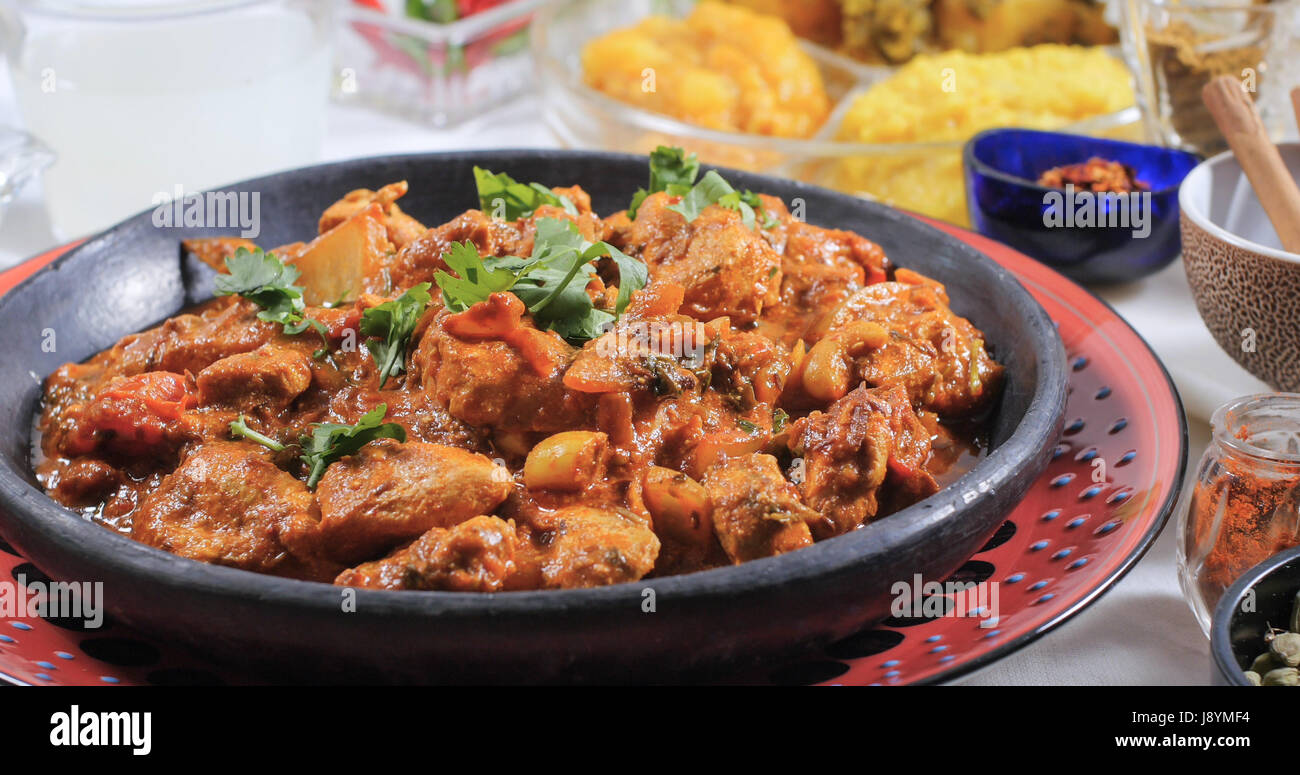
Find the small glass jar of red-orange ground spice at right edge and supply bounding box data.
[1178,393,1300,635]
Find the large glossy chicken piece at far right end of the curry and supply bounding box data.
[822,275,1002,416]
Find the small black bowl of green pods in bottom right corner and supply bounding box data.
[1210,546,1300,687]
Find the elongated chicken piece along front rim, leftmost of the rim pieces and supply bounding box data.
[334,516,515,592]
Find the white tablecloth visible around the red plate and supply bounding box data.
[0,72,1266,684]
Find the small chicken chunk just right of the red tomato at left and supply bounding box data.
[196,345,312,411]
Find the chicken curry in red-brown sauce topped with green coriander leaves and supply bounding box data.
[36,148,1002,592]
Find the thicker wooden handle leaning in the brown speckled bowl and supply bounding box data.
[1201,75,1300,254]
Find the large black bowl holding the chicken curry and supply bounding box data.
[0,151,1066,683]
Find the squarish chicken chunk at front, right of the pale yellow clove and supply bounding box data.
[703,454,820,564]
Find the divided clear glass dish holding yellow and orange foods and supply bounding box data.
[533,0,1141,225]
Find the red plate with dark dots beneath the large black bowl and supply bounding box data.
[0,221,1187,685]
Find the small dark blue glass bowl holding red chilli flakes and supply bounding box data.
[963,129,1199,283]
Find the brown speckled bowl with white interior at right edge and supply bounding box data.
[1178,143,1300,393]
